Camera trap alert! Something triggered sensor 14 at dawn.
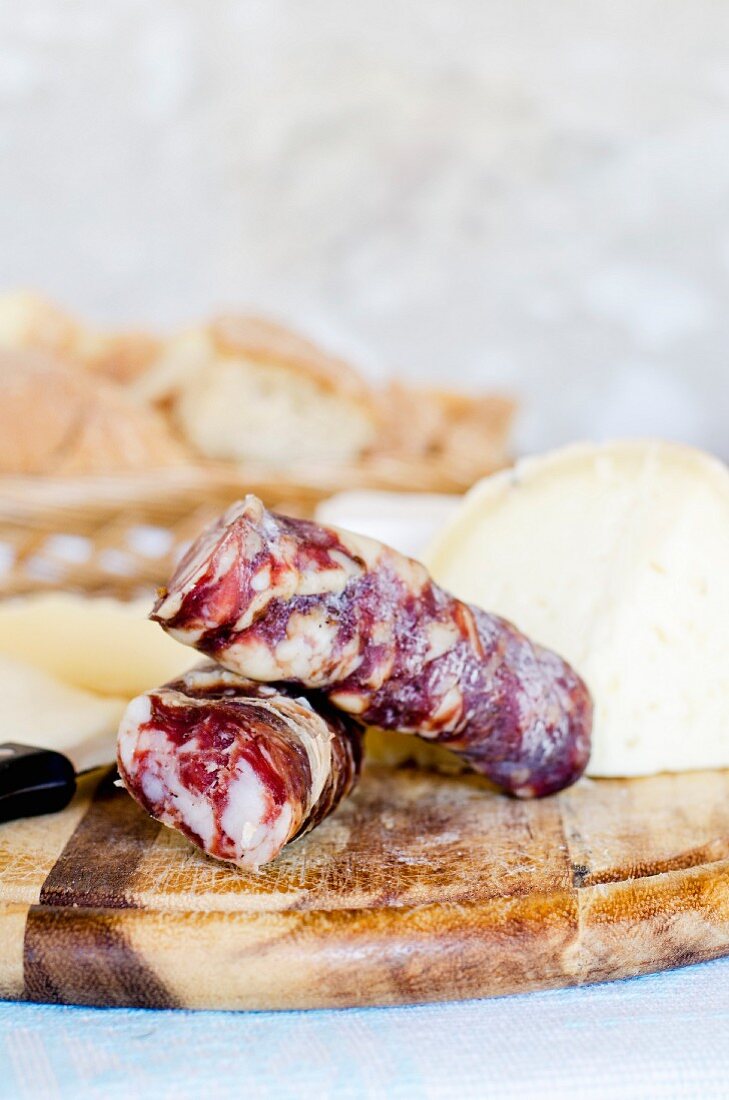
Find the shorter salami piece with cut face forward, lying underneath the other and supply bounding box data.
[118,663,362,869]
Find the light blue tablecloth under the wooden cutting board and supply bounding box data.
[0,959,729,1100]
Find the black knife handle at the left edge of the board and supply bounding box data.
[0,741,76,822]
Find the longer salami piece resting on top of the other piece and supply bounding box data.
[152,496,592,798]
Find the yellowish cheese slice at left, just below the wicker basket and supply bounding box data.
[0,592,193,699]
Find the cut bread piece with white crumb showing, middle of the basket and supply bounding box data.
[133,316,378,469]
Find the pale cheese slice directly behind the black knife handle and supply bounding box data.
[0,657,126,771]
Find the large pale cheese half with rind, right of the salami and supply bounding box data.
[424,441,729,776]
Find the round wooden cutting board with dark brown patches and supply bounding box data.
[0,766,729,1009]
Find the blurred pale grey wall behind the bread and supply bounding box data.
[0,0,729,457]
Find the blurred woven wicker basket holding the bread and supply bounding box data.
[0,451,492,597]
